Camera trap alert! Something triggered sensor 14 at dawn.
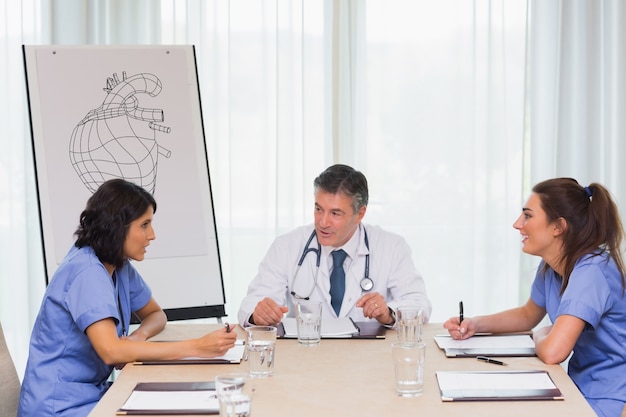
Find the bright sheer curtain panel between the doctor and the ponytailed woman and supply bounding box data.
[353,0,527,321]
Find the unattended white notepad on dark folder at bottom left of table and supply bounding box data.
[116,381,219,415]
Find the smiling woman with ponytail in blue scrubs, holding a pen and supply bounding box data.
[444,178,626,417]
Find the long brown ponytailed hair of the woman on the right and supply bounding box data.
[533,178,626,294]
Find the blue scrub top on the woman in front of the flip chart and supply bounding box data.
[18,246,152,417]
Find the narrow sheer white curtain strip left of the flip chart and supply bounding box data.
[0,0,45,384]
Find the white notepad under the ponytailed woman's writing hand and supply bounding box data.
[435,334,535,358]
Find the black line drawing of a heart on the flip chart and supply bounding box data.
[69,72,171,194]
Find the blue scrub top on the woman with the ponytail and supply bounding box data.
[531,253,626,417]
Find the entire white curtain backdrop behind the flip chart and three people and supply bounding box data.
[0,0,626,380]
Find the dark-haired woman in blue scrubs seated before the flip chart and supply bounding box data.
[18,179,236,417]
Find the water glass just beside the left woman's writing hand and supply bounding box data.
[246,326,276,377]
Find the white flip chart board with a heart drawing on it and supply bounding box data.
[23,45,226,320]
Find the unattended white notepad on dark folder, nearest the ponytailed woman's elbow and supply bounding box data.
[435,370,563,401]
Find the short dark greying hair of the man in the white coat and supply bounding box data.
[313,164,369,213]
